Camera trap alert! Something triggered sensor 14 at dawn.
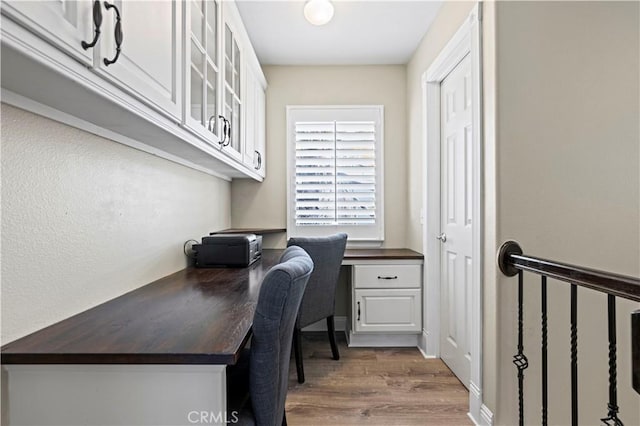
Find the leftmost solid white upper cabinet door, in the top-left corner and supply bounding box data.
[1,0,94,66]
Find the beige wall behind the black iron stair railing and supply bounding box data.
[485,2,640,424]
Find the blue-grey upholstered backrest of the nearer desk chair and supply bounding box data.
[249,247,313,426]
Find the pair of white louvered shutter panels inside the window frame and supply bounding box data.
[295,121,377,226]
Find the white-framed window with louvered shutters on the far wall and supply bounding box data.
[287,106,384,242]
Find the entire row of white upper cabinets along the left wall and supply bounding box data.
[0,0,266,180]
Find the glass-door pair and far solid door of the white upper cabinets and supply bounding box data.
[184,0,266,173]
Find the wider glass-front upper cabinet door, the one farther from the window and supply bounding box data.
[184,0,228,147]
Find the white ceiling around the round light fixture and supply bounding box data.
[237,0,442,65]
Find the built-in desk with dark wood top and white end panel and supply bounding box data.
[2,249,422,426]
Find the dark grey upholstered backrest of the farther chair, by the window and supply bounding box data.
[287,233,347,328]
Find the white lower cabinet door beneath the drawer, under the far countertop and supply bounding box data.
[353,289,422,333]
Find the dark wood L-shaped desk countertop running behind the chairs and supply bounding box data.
[1,249,423,365]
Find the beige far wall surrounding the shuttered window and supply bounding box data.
[231,65,408,247]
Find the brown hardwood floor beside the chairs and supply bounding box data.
[286,333,472,426]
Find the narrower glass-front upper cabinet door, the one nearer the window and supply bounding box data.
[222,14,244,161]
